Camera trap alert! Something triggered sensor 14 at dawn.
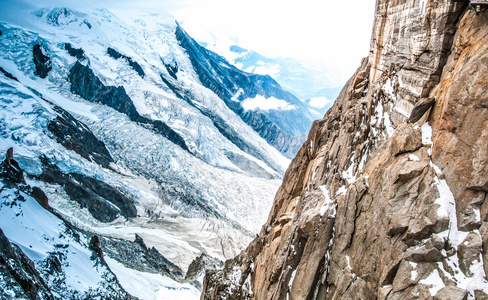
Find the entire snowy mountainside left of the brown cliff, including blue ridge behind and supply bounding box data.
[0,3,314,299]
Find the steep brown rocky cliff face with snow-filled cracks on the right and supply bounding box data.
[202,0,488,299]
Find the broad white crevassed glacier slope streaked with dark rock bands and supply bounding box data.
[0,4,302,298]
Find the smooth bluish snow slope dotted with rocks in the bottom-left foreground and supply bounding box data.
[0,182,132,299]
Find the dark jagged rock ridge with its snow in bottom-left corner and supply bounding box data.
[0,154,136,300]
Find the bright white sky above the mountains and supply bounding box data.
[0,0,375,86]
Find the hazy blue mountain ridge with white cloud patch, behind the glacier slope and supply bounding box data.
[175,25,321,158]
